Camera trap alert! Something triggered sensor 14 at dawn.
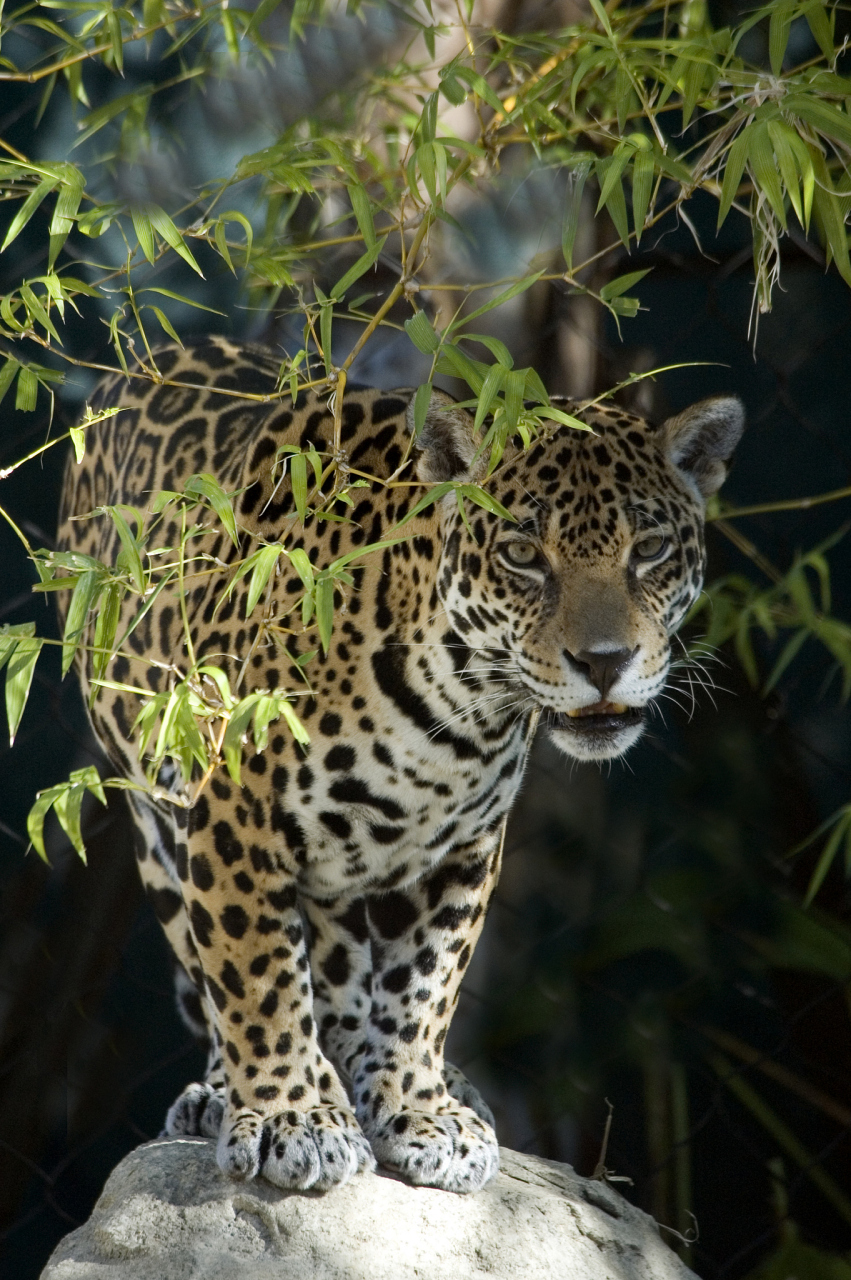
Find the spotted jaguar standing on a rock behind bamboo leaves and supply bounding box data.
[59,337,744,1192]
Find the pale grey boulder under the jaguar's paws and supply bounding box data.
[41,1138,694,1280]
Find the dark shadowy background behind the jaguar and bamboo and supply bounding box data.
[0,5,851,1280]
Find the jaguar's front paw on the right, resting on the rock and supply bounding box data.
[369,1107,499,1194]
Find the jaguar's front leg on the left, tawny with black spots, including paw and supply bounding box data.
[167,786,374,1189]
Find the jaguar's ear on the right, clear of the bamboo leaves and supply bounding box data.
[662,396,745,498]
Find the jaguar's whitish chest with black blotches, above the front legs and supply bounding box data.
[243,650,532,897]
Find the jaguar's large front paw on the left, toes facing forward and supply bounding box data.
[216,1106,375,1190]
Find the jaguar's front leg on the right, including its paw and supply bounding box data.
[352,827,503,1192]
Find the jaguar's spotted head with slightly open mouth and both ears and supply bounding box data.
[409,393,744,760]
